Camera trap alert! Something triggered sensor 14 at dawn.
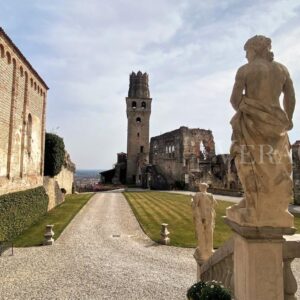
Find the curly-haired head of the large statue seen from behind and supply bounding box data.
[244,35,274,62]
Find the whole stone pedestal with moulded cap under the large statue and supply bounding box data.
[225,218,295,300]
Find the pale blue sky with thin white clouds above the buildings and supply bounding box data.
[0,0,300,169]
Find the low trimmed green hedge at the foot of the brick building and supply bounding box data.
[0,186,49,240]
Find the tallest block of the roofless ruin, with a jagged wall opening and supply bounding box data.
[150,127,215,185]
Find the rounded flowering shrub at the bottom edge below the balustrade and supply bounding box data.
[186,280,231,300]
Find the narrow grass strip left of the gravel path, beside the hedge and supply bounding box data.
[14,193,93,247]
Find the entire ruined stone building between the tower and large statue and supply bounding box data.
[149,127,241,194]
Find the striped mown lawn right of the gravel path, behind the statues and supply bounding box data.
[124,192,300,248]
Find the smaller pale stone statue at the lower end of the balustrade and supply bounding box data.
[191,183,217,261]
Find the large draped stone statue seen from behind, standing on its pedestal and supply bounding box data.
[227,35,295,227]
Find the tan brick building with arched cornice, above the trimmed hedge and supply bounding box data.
[0,28,48,195]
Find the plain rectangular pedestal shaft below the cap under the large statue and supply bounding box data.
[234,235,284,300]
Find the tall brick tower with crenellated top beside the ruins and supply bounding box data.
[126,71,152,186]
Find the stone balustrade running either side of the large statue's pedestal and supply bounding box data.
[195,234,300,300]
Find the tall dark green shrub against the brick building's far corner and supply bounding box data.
[44,133,65,177]
